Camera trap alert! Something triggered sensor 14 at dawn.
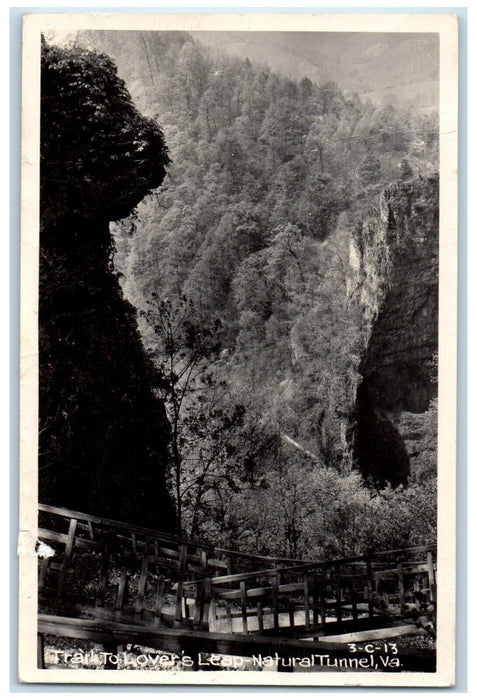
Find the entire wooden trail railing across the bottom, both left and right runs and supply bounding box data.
[38,505,437,638]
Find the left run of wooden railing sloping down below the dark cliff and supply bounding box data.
[38,505,318,624]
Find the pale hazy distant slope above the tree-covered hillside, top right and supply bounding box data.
[192,31,439,112]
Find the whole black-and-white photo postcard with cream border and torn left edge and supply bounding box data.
[18,12,458,687]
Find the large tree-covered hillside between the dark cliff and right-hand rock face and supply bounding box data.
[76,32,438,556]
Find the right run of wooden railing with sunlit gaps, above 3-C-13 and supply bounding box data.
[184,545,436,636]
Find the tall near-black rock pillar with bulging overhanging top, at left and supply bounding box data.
[39,39,174,530]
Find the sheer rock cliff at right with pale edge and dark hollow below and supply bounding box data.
[352,177,439,486]
